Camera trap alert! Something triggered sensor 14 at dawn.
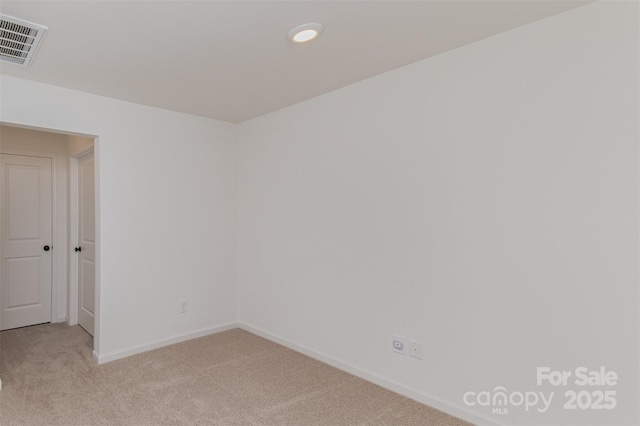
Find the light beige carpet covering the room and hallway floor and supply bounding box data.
[0,324,468,426]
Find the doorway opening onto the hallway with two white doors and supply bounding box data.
[0,124,99,348]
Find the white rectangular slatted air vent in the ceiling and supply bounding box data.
[0,14,47,67]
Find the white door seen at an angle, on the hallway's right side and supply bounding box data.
[75,153,96,336]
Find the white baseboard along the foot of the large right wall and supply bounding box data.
[237,322,498,425]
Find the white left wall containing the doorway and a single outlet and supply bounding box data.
[0,76,236,361]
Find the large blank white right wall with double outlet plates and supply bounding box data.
[238,2,640,425]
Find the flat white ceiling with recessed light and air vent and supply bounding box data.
[0,0,586,123]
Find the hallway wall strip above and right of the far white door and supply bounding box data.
[0,126,68,322]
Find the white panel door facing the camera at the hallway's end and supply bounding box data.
[0,154,53,330]
